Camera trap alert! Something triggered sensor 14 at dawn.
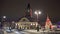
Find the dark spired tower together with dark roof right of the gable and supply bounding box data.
[24,3,36,22]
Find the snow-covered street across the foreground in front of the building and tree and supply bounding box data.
[4,30,60,34]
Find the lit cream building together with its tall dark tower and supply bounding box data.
[15,3,38,29]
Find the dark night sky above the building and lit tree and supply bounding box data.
[0,0,60,22]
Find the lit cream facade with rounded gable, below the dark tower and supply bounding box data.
[15,17,38,29]
